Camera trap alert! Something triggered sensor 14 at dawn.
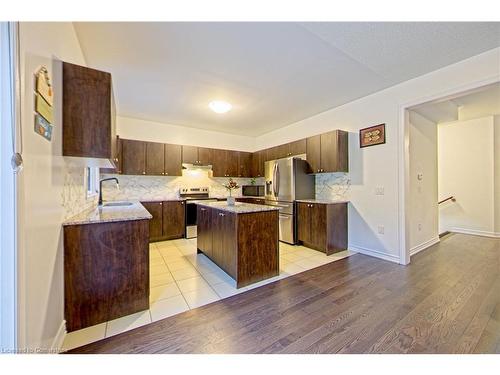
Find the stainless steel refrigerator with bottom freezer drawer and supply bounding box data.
[265,156,315,244]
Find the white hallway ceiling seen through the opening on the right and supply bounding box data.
[411,83,500,123]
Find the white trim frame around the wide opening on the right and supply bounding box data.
[398,75,500,265]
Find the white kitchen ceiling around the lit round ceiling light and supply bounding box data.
[75,22,500,136]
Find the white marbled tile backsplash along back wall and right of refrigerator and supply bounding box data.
[96,171,351,200]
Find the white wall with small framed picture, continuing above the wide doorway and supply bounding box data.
[256,48,500,261]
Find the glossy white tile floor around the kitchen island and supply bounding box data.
[63,238,352,350]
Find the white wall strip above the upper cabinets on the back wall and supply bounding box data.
[116,116,255,151]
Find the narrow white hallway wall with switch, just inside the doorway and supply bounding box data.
[408,111,439,253]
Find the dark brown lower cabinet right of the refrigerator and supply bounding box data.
[297,202,347,255]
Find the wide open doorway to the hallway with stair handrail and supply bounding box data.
[405,82,500,261]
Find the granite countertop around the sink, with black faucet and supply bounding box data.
[63,202,153,226]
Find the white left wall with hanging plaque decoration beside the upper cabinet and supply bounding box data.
[19,23,93,348]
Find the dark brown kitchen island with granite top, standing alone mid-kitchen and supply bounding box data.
[197,202,279,288]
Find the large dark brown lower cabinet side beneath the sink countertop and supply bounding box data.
[64,220,149,332]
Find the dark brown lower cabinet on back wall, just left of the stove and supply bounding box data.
[141,201,186,242]
